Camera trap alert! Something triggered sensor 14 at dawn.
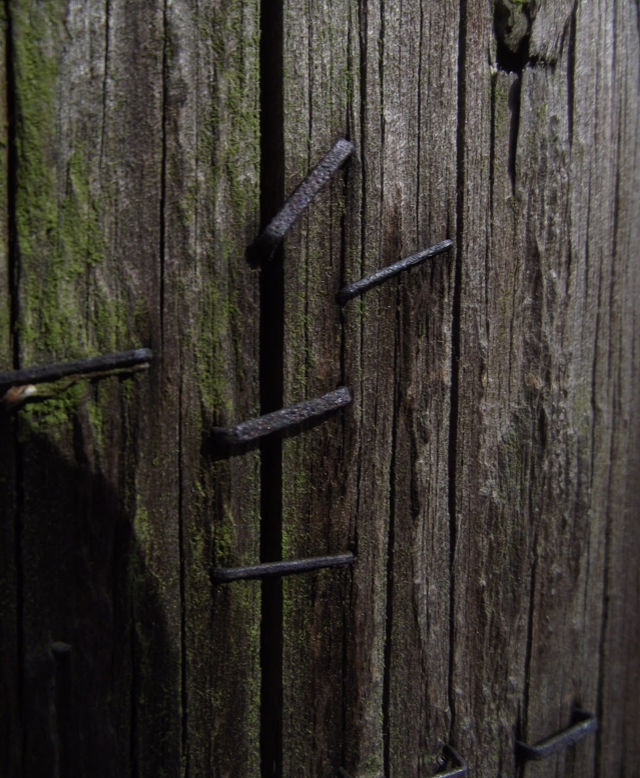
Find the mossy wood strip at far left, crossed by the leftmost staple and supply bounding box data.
[9,2,181,775]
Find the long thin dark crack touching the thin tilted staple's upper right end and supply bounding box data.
[448,0,468,743]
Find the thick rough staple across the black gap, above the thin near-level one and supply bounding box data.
[212,386,351,449]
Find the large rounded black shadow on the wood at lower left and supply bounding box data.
[0,416,180,778]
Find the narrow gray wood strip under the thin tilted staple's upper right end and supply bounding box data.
[383,1,459,776]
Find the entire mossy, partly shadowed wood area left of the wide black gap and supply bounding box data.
[0,0,259,776]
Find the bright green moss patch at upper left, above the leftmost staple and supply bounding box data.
[14,2,123,359]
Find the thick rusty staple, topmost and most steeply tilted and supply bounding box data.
[247,138,353,264]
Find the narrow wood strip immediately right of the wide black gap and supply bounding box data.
[282,2,352,775]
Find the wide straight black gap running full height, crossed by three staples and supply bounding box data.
[259,0,284,778]
